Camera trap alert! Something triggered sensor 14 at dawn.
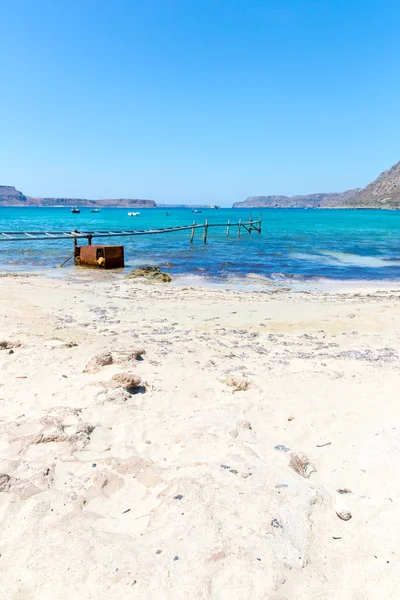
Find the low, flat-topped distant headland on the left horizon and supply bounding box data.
[0,185,157,208]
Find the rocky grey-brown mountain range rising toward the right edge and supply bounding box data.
[233,162,400,209]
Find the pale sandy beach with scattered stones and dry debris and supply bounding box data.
[0,271,400,600]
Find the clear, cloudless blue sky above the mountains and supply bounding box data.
[0,0,400,206]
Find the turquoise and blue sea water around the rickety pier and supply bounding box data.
[0,208,400,281]
